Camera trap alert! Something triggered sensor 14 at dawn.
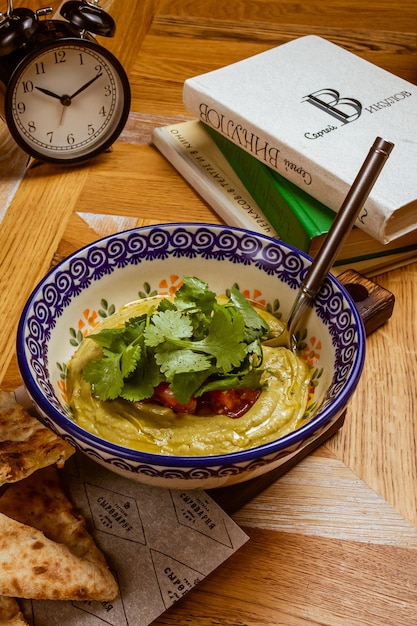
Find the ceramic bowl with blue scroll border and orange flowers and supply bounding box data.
[17,224,365,489]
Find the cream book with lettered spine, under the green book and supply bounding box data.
[152,120,277,237]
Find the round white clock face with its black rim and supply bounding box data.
[5,39,130,163]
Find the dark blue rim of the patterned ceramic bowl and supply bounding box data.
[16,222,365,468]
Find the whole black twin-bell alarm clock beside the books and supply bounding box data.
[0,0,131,164]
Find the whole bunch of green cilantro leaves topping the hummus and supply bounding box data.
[83,277,269,403]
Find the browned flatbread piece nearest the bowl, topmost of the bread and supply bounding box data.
[0,391,75,485]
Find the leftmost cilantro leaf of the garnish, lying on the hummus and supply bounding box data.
[83,355,123,400]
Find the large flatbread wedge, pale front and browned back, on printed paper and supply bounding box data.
[0,467,118,601]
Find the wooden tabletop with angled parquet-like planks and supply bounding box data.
[0,0,417,626]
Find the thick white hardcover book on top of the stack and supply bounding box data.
[183,35,417,243]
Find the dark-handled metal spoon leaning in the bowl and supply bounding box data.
[263,137,394,352]
